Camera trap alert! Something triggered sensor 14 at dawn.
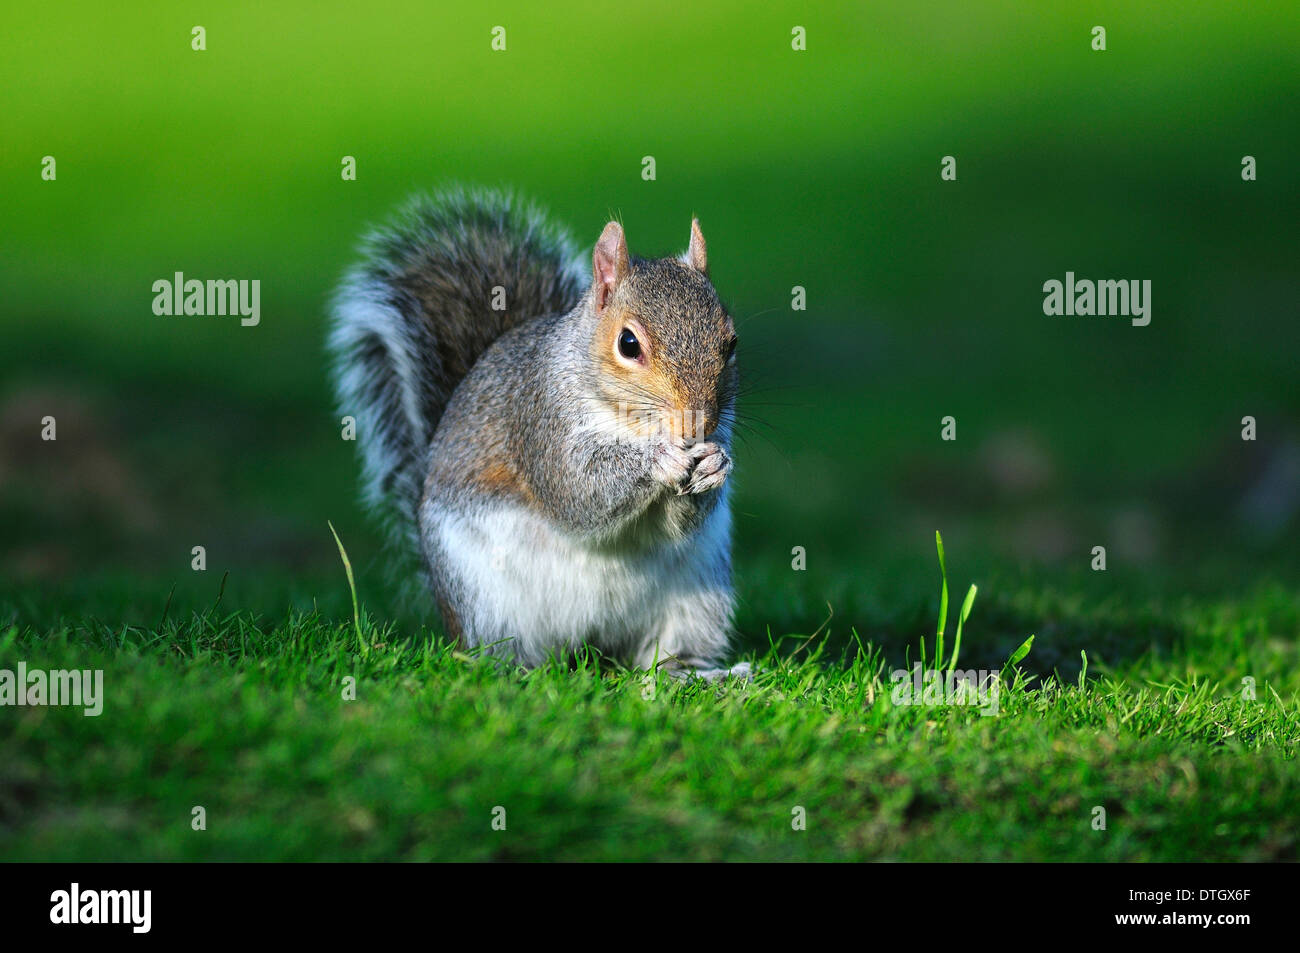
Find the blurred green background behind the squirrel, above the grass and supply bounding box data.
[0,3,1300,662]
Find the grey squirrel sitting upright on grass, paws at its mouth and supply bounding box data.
[329,189,749,679]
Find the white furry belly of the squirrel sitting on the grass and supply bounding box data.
[421,499,732,667]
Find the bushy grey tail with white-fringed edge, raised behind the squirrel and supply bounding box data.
[329,189,588,541]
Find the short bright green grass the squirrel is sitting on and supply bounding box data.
[0,530,1300,861]
